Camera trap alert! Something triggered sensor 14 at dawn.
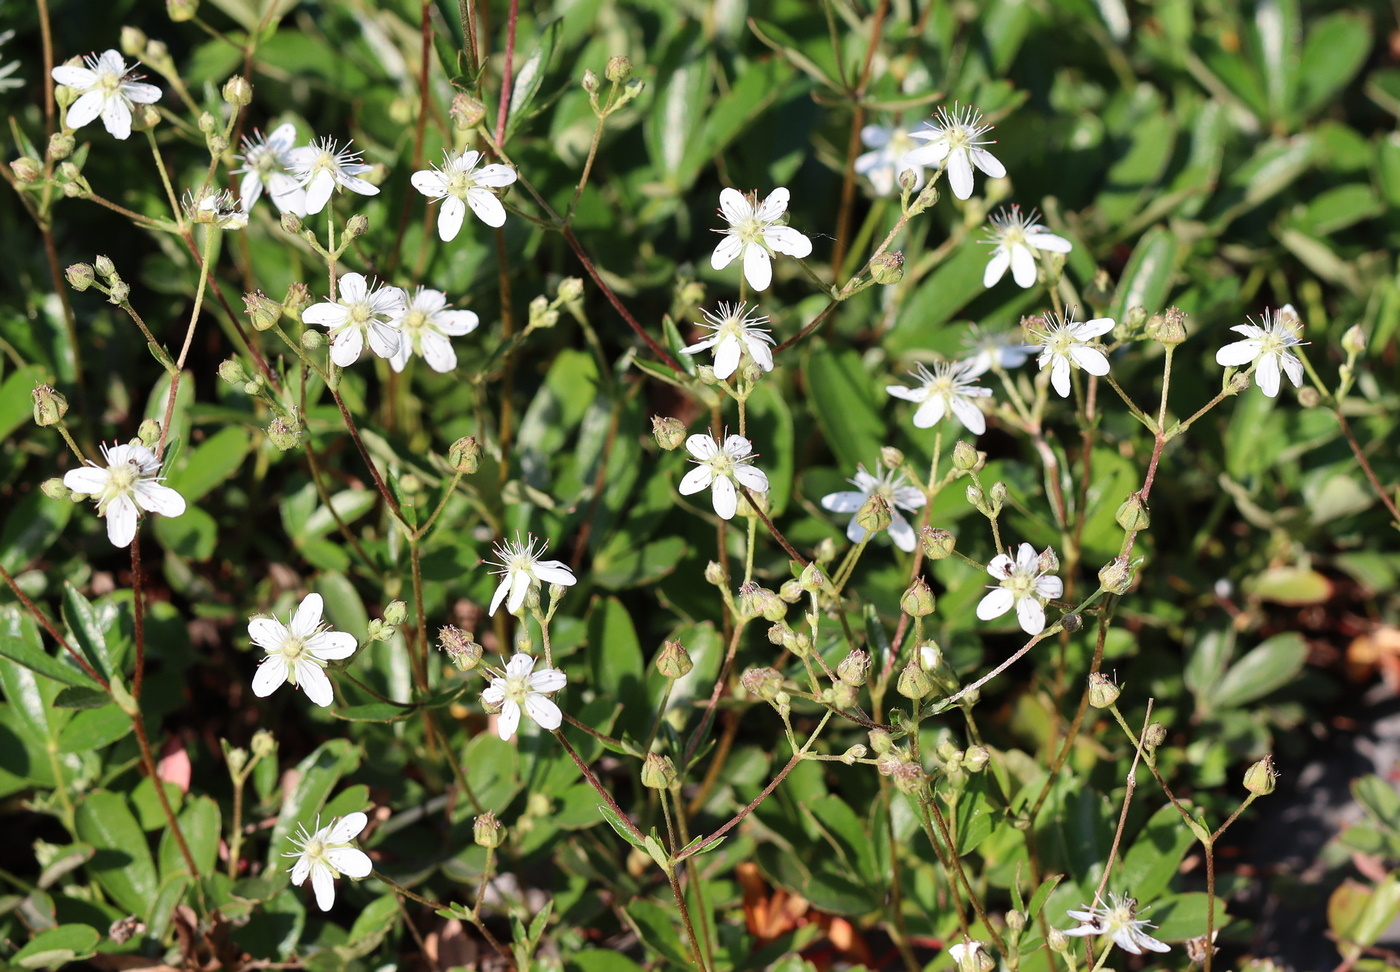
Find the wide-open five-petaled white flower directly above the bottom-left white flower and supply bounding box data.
[248,594,358,708]
